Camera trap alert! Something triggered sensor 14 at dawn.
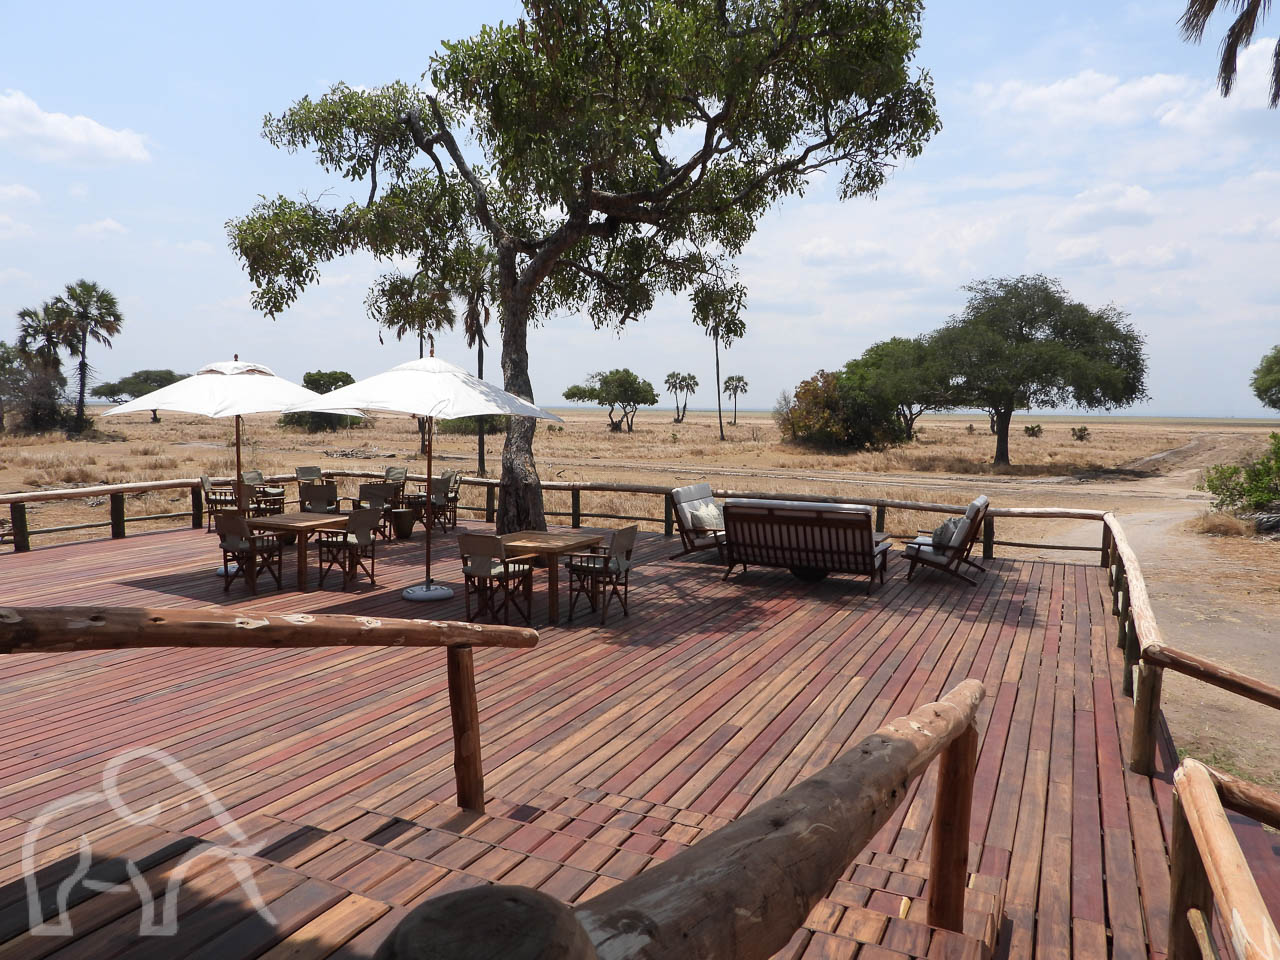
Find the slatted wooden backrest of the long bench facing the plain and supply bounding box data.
[724,499,876,573]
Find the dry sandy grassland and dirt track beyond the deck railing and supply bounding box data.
[0,408,1280,783]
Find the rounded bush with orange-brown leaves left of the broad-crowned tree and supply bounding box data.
[790,370,906,451]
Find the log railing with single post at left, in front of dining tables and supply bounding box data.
[0,607,538,812]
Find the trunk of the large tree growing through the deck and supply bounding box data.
[497,241,547,534]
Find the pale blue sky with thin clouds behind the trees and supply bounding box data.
[0,0,1280,416]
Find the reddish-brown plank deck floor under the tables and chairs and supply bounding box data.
[0,530,1274,960]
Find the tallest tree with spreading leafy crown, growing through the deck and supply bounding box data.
[229,0,938,530]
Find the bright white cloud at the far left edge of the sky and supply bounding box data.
[0,90,151,163]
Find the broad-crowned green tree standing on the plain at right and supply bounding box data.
[933,274,1147,466]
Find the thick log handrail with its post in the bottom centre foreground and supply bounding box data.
[379,680,984,960]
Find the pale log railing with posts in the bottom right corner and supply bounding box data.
[1169,760,1280,960]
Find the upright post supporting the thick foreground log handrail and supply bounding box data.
[928,724,978,933]
